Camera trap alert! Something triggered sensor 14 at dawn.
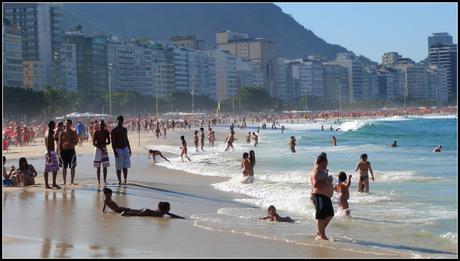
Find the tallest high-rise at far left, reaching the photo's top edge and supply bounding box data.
[3,3,63,89]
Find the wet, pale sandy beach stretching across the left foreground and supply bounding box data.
[2,125,442,258]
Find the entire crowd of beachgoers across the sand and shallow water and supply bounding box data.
[2,105,456,236]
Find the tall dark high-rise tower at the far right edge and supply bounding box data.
[428,41,458,102]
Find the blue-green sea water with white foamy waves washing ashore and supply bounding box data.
[151,116,458,257]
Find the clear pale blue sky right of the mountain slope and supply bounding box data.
[276,3,458,62]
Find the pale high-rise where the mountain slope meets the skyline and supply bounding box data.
[335,53,364,103]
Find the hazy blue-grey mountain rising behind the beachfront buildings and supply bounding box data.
[63,3,347,59]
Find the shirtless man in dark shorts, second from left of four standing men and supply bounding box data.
[58,119,78,185]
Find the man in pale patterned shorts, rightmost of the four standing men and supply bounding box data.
[110,115,132,185]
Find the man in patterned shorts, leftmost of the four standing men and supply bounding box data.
[44,121,61,189]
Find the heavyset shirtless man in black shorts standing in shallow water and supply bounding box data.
[310,152,334,240]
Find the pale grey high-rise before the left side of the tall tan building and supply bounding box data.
[207,50,238,101]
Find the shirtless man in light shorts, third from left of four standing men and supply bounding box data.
[93,120,110,185]
